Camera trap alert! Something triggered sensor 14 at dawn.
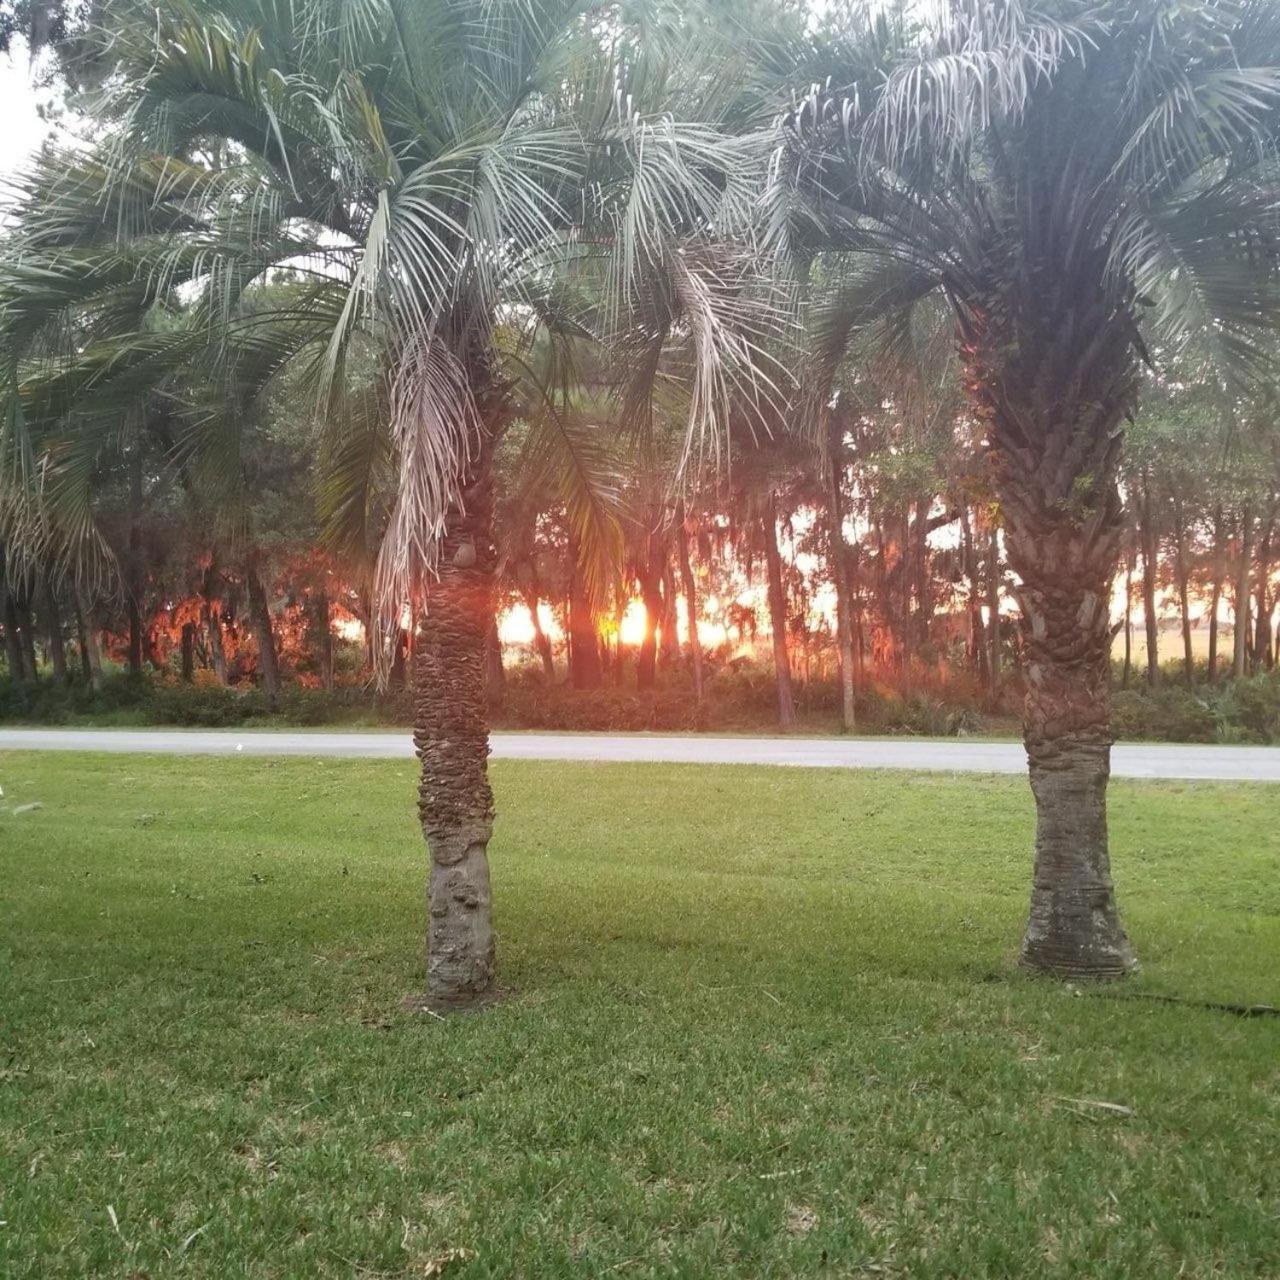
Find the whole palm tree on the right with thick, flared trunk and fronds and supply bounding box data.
[777,0,1280,977]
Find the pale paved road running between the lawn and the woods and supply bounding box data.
[0,728,1280,782]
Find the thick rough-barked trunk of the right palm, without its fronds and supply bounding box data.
[961,241,1137,977]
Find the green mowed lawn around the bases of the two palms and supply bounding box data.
[0,753,1280,1280]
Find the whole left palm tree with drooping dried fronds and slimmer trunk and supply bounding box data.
[4,0,783,1007]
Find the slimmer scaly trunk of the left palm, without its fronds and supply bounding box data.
[413,439,497,1010]
